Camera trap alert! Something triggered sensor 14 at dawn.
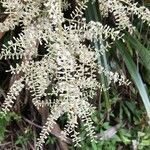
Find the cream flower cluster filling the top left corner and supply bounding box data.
[0,0,41,32]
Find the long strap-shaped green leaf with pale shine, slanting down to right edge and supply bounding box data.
[116,41,150,124]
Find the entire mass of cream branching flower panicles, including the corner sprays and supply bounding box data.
[0,0,150,149]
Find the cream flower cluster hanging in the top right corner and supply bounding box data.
[98,0,150,34]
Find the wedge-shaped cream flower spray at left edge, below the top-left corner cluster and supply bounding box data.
[0,25,39,59]
